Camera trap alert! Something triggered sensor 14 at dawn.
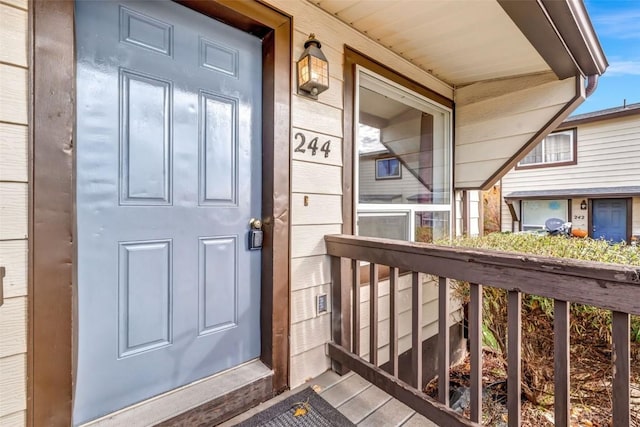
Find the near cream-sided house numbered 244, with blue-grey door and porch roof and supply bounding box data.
[0,0,607,426]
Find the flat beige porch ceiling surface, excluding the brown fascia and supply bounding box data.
[310,0,550,86]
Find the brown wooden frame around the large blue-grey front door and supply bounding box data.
[27,0,292,426]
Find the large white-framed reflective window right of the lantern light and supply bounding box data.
[355,68,453,242]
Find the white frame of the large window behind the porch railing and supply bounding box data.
[352,65,455,242]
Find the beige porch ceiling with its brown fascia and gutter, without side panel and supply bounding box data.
[308,0,608,87]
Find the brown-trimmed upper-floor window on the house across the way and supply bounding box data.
[518,129,576,169]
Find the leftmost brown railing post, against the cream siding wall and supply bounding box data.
[331,256,351,375]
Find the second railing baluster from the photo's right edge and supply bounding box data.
[553,300,571,427]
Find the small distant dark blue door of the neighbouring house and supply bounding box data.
[591,199,627,242]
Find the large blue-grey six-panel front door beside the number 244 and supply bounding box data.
[74,1,262,424]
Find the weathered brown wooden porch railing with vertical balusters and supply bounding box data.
[325,235,640,426]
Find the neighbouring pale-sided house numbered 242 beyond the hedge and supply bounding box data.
[501,104,640,243]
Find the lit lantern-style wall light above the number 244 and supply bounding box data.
[298,34,329,99]
